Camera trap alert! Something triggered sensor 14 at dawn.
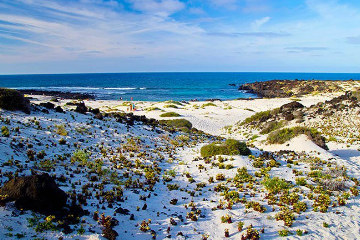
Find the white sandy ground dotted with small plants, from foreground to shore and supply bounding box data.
[0,82,360,239]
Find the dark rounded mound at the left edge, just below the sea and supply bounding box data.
[0,88,30,113]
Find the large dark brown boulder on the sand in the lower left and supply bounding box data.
[0,173,67,213]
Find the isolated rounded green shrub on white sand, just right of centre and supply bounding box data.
[200,139,251,157]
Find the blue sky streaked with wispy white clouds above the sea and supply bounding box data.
[0,0,360,74]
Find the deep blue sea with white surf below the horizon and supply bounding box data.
[0,72,360,101]
